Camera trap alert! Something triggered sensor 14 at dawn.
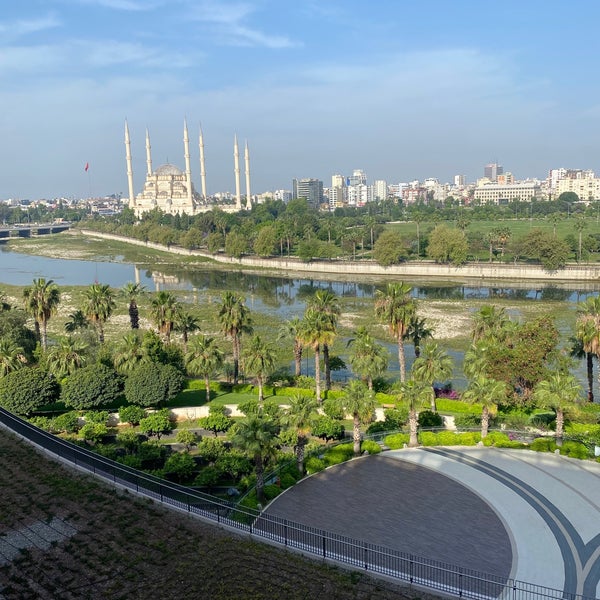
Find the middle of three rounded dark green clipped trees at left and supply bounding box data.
[60,364,123,410]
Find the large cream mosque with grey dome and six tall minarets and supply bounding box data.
[125,121,252,217]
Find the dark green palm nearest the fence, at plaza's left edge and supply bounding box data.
[231,415,277,503]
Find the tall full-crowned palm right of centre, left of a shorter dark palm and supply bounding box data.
[375,282,417,382]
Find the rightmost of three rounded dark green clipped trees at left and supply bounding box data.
[125,363,184,407]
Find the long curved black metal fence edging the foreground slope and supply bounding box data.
[0,408,594,600]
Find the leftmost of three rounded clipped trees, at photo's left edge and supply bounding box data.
[0,367,60,415]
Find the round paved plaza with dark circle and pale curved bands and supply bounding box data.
[268,448,600,597]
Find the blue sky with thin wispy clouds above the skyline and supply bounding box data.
[0,0,600,200]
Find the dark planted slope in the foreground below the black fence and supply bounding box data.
[0,429,432,600]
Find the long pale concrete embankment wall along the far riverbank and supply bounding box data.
[79,230,600,283]
